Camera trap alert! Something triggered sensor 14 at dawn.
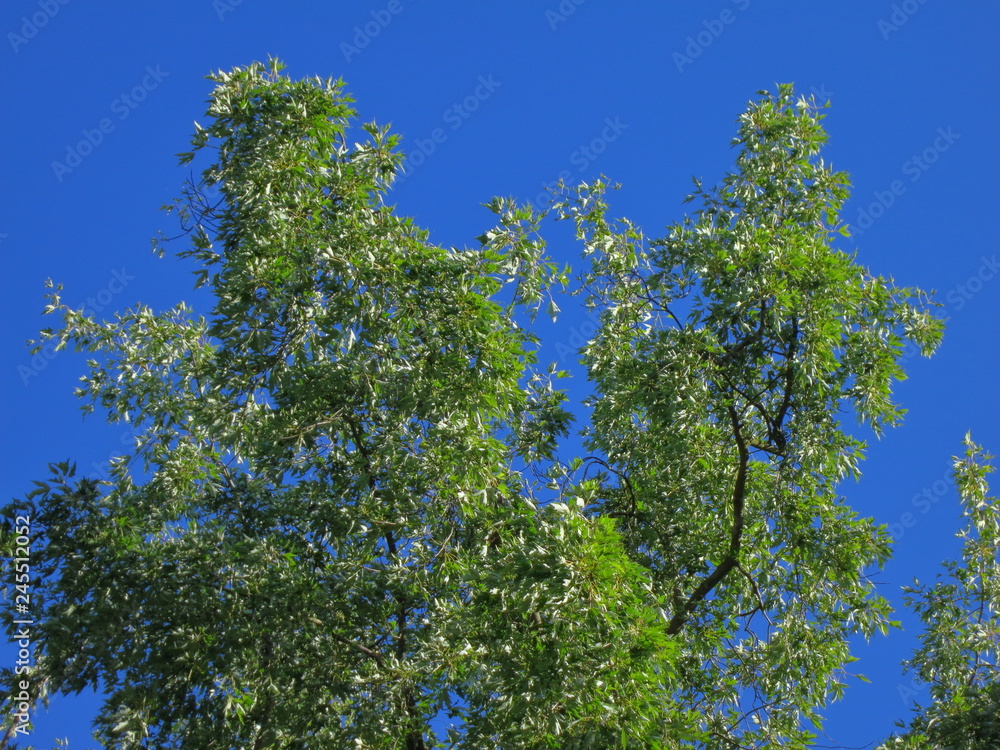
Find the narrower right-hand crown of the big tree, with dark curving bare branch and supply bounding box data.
[532,86,940,747]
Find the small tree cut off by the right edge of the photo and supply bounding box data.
[882,435,1000,750]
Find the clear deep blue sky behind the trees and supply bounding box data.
[0,0,1000,748]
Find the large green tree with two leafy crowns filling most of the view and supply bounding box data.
[4,61,941,750]
